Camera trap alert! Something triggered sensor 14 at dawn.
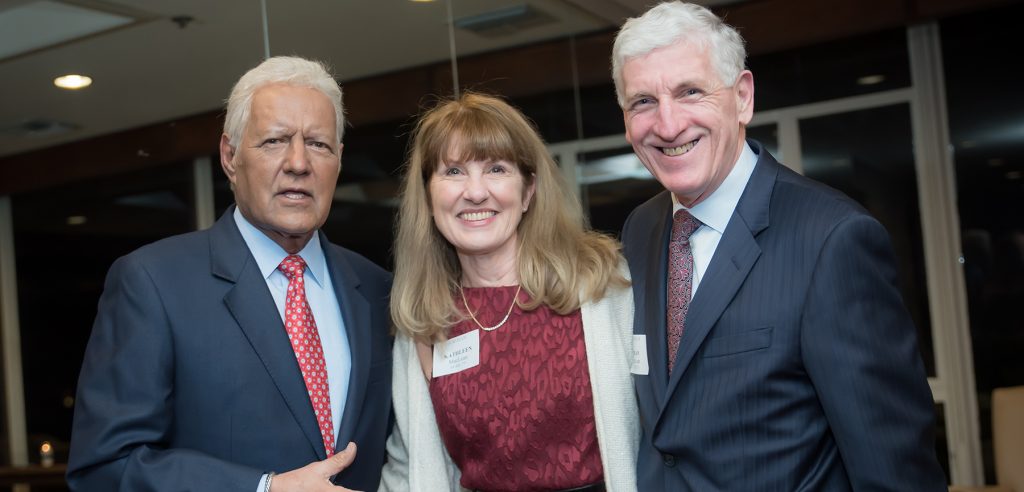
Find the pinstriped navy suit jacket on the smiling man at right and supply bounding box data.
[623,140,946,492]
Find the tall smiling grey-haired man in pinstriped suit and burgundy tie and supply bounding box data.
[612,2,945,492]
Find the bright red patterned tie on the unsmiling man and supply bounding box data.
[278,254,334,457]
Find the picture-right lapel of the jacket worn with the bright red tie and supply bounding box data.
[321,233,372,450]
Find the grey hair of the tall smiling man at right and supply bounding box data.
[611,1,746,107]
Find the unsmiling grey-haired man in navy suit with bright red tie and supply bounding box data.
[68,57,391,492]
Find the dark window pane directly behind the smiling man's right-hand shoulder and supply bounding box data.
[800,104,935,376]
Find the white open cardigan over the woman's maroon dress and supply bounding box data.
[379,278,640,492]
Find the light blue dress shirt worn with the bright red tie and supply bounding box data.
[233,207,352,491]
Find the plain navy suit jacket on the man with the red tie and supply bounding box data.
[68,208,391,492]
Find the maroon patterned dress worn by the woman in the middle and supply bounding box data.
[430,286,603,491]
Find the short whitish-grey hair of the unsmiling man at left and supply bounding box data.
[224,56,345,146]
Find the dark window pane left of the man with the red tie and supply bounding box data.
[11,163,195,462]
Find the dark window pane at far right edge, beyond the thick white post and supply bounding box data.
[940,3,1024,484]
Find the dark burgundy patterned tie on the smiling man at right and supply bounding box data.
[667,209,700,374]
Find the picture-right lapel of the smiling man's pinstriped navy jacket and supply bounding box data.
[662,141,779,413]
